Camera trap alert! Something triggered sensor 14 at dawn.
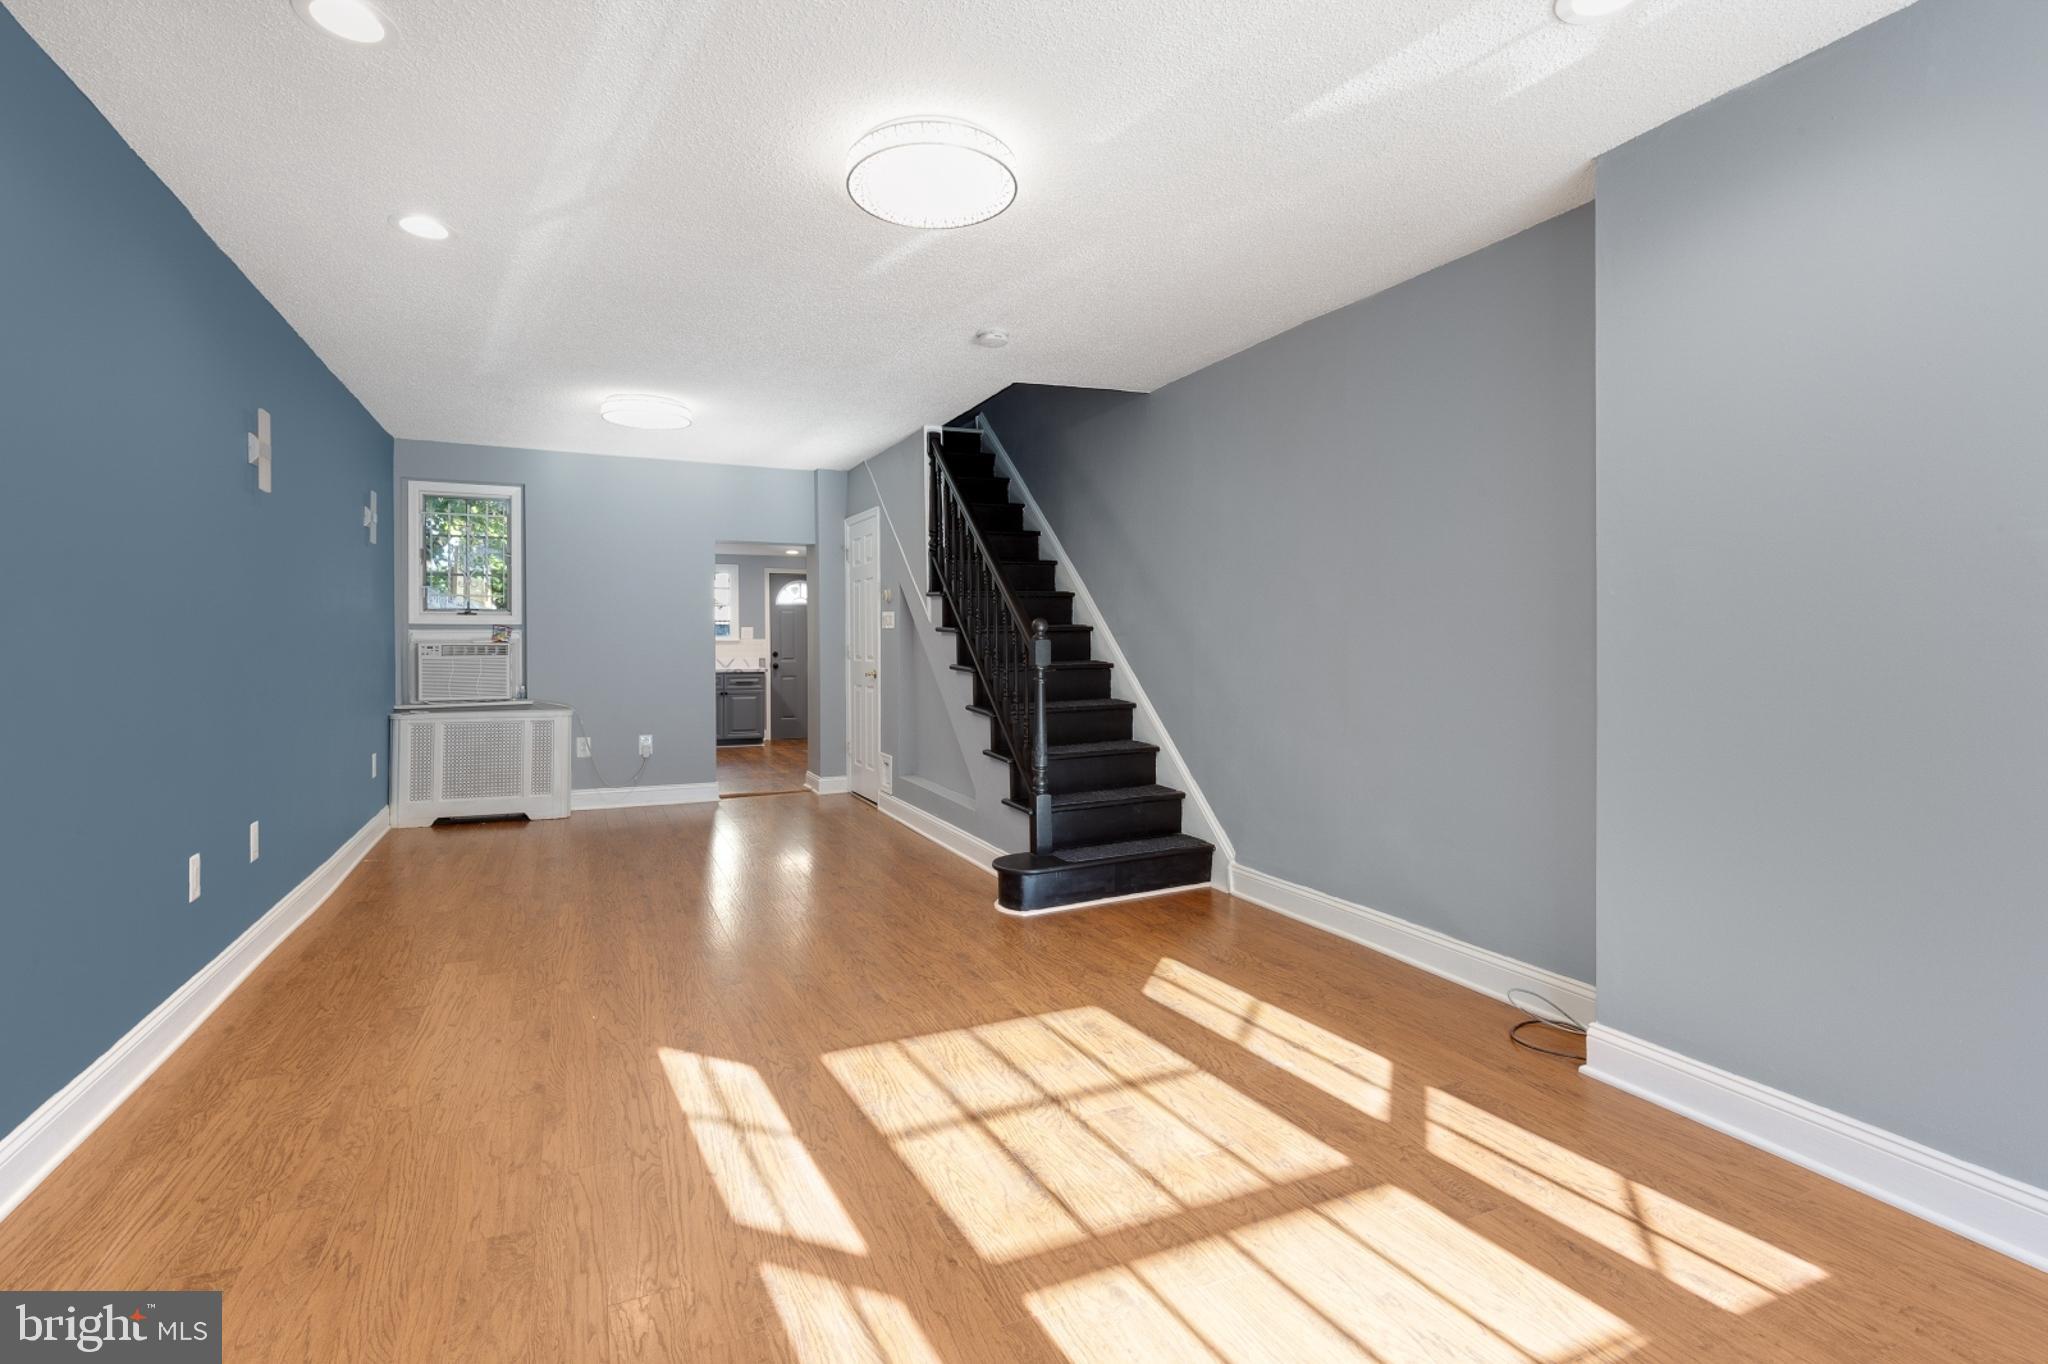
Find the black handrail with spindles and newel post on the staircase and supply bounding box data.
[926,432,1053,852]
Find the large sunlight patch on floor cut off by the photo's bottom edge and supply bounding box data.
[1024,1186,1642,1364]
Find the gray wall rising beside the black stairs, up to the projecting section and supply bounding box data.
[985,209,1593,981]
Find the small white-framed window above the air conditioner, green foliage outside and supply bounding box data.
[408,483,526,625]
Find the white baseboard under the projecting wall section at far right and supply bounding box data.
[1581,1024,2048,1270]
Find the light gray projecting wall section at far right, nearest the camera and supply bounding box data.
[1597,0,2048,1184]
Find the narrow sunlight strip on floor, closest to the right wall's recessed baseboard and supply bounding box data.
[1145,956,1395,1122]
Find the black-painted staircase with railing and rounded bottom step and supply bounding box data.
[926,428,1214,911]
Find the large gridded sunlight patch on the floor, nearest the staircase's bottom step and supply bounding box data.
[823,1008,1346,1262]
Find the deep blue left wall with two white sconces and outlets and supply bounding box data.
[0,10,391,1133]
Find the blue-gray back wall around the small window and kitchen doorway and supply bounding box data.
[391,440,819,786]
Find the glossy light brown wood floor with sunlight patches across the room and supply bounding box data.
[0,797,2048,1364]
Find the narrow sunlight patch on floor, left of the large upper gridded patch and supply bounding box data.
[662,1047,868,1255]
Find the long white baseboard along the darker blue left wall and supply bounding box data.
[0,809,391,1217]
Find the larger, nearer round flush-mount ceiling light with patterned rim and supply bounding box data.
[846,119,1018,227]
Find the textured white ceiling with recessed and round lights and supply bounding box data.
[6,0,1905,469]
